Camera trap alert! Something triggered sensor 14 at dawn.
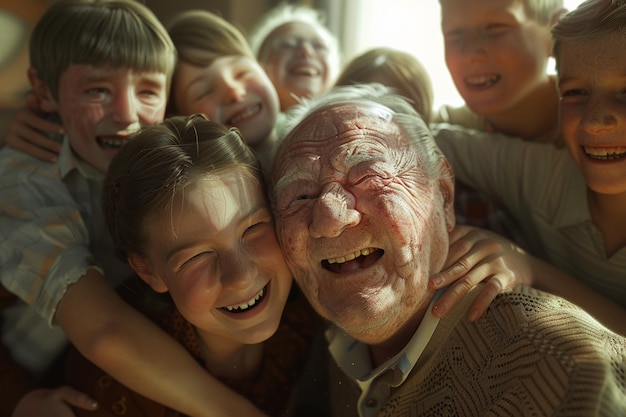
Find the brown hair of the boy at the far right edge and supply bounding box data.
[552,0,626,65]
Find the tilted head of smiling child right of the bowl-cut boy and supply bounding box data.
[168,10,279,148]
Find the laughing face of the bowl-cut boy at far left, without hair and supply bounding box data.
[46,64,167,172]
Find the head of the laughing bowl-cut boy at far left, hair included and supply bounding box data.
[29,0,176,171]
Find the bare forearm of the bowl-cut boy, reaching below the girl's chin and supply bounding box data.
[55,269,263,417]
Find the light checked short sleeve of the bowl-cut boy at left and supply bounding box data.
[0,149,94,325]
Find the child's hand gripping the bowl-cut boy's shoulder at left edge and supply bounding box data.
[5,92,63,161]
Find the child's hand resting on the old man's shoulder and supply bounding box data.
[429,225,532,321]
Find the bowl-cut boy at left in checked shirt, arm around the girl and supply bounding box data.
[0,0,266,415]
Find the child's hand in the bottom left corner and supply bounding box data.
[12,385,98,417]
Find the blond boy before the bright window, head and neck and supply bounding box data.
[440,0,565,142]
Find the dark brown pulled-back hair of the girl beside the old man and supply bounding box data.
[102,114,263,260]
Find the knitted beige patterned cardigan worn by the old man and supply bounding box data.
[331,287,626,417]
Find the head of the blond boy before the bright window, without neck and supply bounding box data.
[440,0,563,116]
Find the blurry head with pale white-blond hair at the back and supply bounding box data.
[250,3,339,110]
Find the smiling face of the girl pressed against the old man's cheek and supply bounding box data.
[130,170,291,349]
